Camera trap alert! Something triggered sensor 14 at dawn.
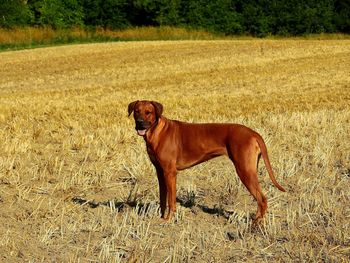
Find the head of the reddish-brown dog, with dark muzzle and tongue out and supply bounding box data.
[128,100,163,136]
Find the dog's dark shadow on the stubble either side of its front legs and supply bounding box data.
[72,196,238,219]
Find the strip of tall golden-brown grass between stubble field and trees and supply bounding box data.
[0,26,220,51]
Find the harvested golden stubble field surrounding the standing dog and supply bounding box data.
[0,40,350,262]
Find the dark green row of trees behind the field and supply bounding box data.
[0,0,350,37]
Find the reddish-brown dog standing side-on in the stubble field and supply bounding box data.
[128,101,285,221]
